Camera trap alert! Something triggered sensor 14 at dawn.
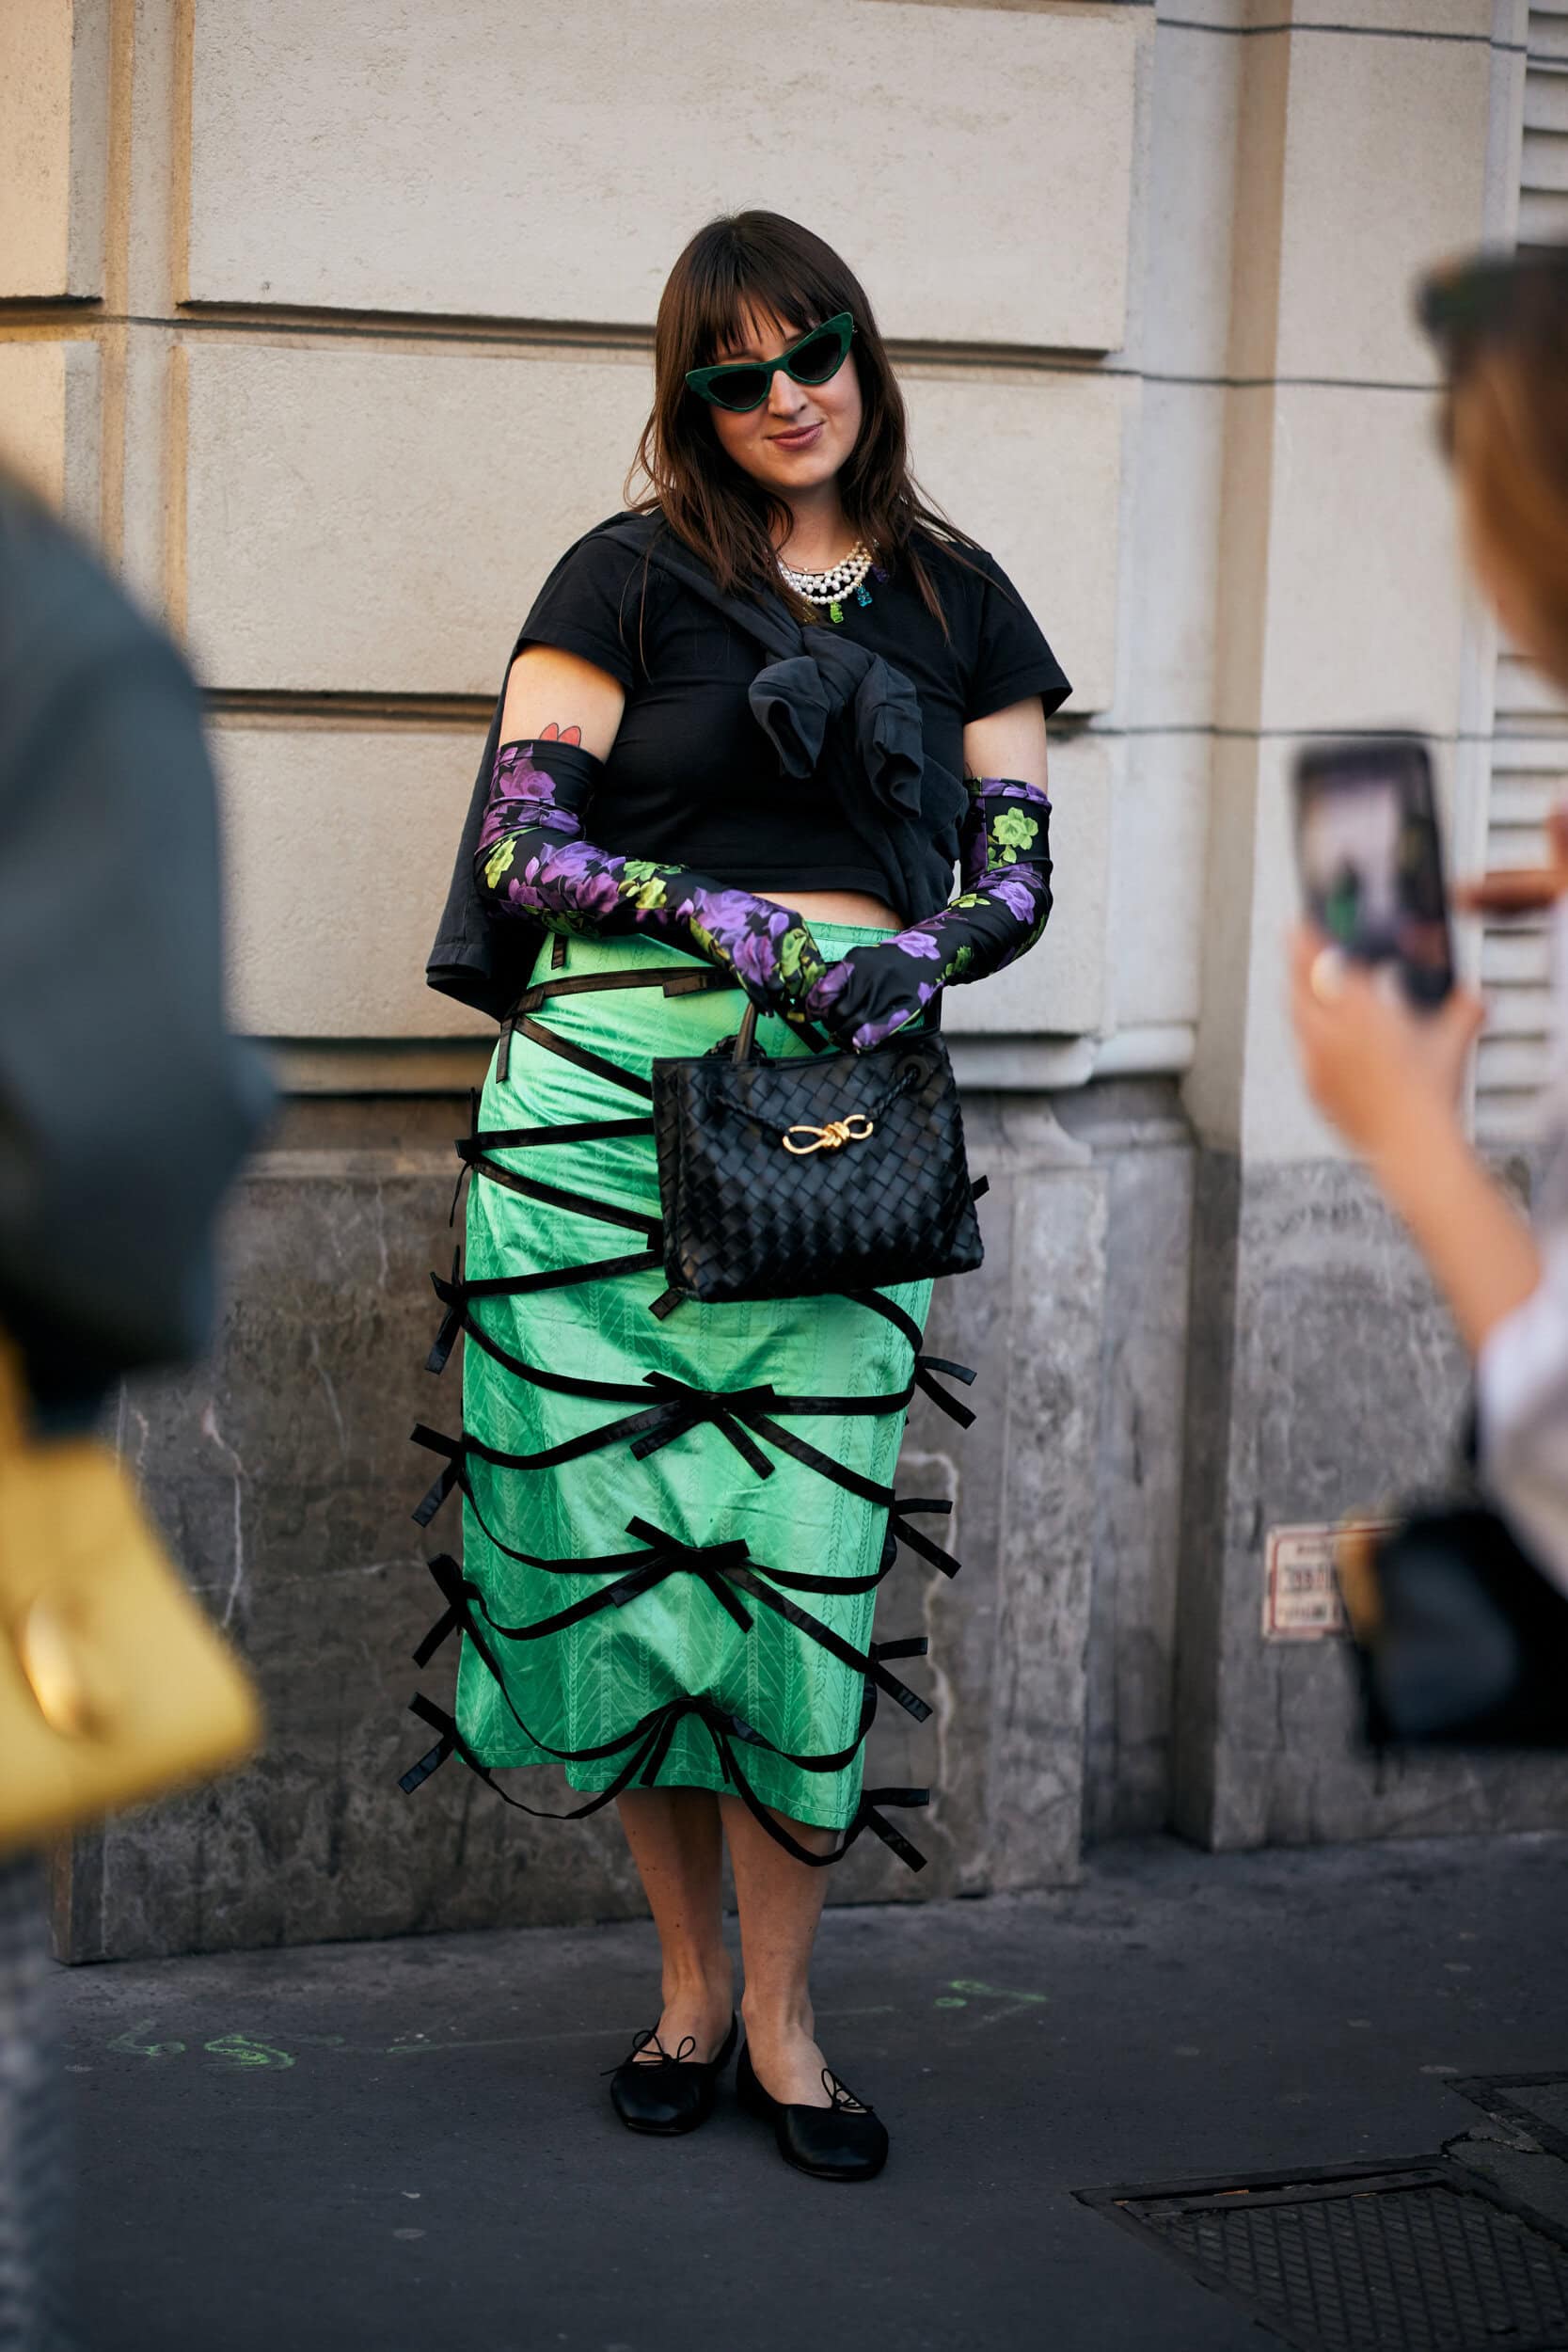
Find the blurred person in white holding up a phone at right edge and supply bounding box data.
[1291,249,1568,1637]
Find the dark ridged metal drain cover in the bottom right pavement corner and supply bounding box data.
[1079,2157,1568,2352]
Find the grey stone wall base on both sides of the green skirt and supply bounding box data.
[56,1089,1192,1960]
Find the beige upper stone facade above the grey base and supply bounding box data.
[0,0,1526,1110]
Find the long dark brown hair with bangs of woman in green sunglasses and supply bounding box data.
[626,212,974,630]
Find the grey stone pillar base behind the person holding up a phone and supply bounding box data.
[1171,1152,1568,1847]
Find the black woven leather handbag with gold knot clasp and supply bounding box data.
[654,1000,983,1311]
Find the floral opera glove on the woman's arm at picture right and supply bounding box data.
[806,776,1051,1052]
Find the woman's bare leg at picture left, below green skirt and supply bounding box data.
[616,1788,736,2060]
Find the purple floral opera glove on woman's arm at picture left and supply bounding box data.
[475,729,828,1021]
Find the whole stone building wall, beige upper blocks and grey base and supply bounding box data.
[0,0,1566,1957]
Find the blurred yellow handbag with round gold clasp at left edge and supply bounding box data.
[0,1341,261,1853]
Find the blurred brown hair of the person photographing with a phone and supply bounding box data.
[1432,247,1568,687]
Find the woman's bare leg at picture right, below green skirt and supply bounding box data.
[720,1797,860,2107]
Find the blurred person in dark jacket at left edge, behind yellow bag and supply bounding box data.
[0,469,268,2352]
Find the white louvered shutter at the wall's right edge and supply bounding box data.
[1477,0,1568,1143]
